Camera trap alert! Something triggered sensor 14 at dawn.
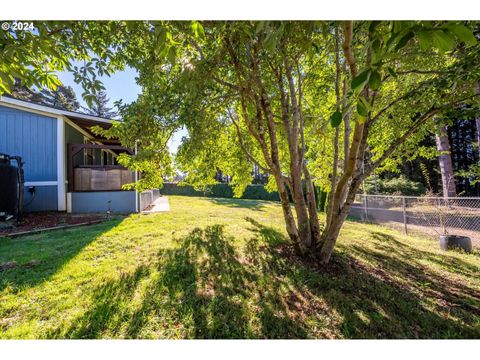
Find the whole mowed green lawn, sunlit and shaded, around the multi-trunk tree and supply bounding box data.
[0,196,480,338]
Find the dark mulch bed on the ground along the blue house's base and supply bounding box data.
[0,212,106,235]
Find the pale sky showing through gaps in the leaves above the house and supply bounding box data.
[58,67,187,153]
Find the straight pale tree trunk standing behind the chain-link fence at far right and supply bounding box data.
[435,119,457,197]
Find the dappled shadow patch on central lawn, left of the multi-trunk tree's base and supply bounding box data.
[129,225,306,339]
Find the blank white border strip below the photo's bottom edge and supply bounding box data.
[0,340,478,360]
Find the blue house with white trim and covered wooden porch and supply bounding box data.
[0,96,158,213]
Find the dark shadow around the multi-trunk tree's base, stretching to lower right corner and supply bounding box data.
[244,220,480,338]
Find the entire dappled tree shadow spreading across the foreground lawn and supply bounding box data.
[51,218,480,338]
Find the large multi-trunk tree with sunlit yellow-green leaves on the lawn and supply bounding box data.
[107,21,479,263]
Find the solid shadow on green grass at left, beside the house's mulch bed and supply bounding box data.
[0,219,122,292]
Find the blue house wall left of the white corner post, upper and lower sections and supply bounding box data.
[0,106,58,211]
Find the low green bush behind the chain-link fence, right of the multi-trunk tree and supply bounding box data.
[365,175,425,196]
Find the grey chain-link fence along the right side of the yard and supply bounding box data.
[350,195,480,247]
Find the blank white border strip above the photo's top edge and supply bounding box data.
[1,0,479,20]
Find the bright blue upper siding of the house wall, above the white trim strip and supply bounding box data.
[0,106,57,181]
